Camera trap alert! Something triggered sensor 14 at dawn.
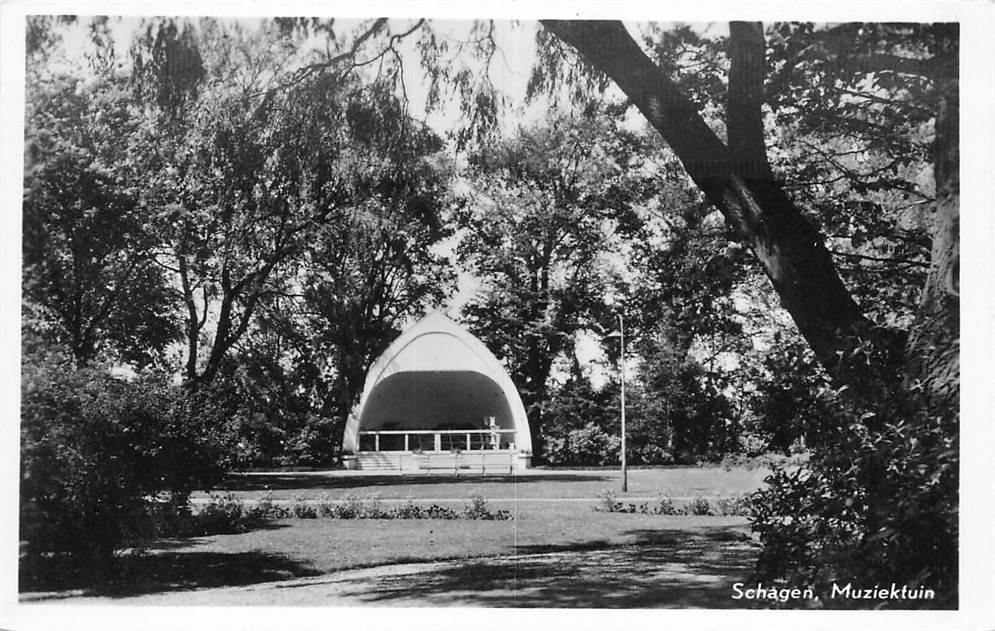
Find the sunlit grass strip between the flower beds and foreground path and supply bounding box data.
[146,504,748,574]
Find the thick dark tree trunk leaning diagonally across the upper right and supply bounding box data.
[543,20,888,386]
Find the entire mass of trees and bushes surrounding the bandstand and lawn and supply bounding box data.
[21,17,959,604]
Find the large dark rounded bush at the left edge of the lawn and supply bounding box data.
[20,354,233,570]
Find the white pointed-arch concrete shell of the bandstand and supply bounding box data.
[342,311,532,452]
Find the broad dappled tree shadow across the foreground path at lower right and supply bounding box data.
[346,527,756,608]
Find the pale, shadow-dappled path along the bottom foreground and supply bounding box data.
[27,538,755,608]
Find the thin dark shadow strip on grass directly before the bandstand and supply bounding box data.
[219,473,614,491]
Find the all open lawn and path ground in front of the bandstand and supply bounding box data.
[21,467,767,608]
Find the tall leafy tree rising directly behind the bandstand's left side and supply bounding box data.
[301,94,455,437]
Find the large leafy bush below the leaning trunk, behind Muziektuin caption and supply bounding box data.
[751,382,958,607]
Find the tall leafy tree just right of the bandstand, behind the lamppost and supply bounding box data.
[458,109,651,457]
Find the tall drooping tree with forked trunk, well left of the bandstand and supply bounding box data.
[133,21,353,384]
